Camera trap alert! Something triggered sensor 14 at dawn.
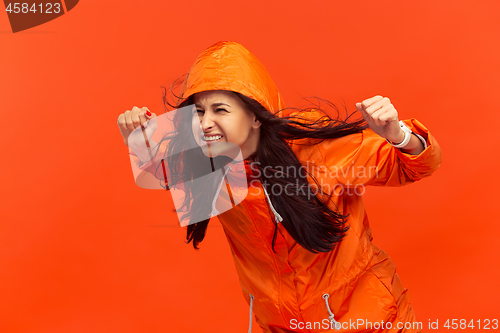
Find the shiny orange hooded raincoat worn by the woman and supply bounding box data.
[131,42,441,332]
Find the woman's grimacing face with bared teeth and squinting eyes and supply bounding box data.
[193,90,261,159]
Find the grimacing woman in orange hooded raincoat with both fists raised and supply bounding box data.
[118,42,441,332]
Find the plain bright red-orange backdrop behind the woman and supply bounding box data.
[0,0,500,333]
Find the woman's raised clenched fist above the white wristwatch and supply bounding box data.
[356,95,405,144]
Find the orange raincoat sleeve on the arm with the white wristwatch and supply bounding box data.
[292,111,442,187]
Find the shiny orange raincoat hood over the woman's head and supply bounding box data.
[177,41,285,113]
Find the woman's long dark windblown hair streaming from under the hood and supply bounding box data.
[156,74,368,253]
